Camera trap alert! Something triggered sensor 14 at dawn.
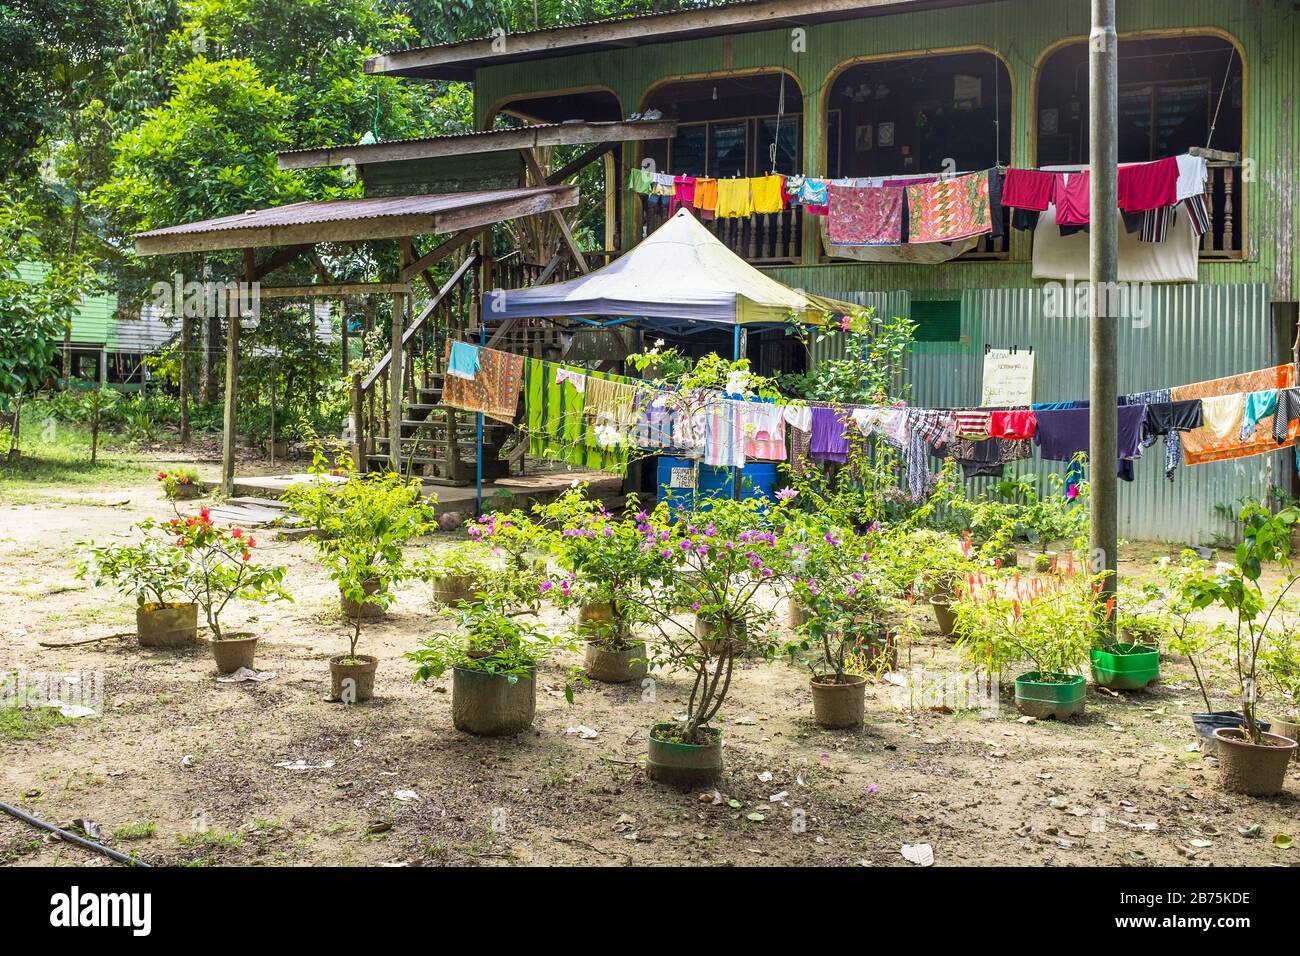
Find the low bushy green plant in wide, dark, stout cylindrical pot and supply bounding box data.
[406,597,572,736]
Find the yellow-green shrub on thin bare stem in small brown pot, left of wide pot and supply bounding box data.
[289,463,434,704]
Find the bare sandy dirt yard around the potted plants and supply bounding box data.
[0,470,1300,866]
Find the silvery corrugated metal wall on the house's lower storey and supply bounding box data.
[813,285,1295,544]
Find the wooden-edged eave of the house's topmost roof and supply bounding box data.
[365,0,991,81]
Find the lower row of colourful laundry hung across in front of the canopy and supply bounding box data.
[443,342,1300,499]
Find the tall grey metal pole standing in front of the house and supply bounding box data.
[1088,0,1121,636]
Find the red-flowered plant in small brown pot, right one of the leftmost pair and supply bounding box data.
[168,509,289,674]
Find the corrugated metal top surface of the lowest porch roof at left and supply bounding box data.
[135,186,568,239]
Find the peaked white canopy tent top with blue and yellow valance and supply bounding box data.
[484,209,861,325]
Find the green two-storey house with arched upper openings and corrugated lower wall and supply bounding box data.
[317,0,1300,541]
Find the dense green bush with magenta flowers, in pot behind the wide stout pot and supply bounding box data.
[534,484,660,684]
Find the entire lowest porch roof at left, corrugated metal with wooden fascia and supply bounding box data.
[135,186,577,256]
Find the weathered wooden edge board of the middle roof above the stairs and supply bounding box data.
[276,120,677,169]
